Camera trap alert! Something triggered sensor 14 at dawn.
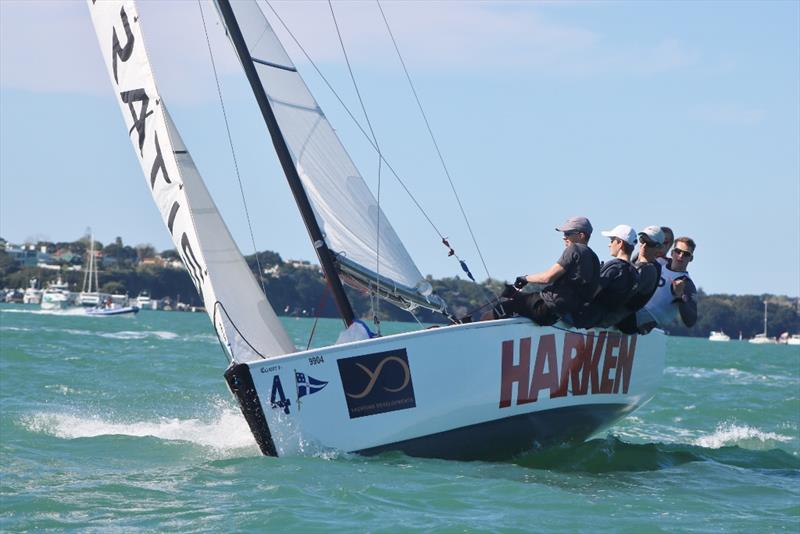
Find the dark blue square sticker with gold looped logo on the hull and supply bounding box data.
[336,349,417,419]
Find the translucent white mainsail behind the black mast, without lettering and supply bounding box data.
[216,0,444,316]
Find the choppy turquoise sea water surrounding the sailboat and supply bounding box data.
[0,305,800,533]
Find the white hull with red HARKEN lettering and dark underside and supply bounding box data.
[226,319,665,459]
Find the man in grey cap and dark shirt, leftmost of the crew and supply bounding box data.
[496,217,600,328]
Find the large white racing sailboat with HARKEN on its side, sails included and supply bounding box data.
[88,0,665,459]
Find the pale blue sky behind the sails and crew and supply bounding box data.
[0,0,800,297]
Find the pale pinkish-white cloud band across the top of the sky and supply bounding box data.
[0,0,695,100]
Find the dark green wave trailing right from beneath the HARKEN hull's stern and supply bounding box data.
[512,435,800,476]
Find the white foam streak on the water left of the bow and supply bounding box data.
[22,401,257,453]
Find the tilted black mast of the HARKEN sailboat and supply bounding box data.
[212,0,355,326]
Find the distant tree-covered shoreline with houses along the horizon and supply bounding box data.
[0,236,800,338]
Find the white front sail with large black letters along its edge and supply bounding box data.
[87,0,295,362]
